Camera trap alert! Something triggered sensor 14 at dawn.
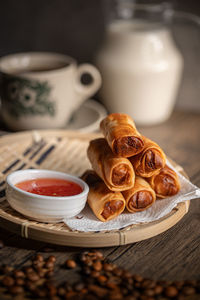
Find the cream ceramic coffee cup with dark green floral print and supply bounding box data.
[0,52,101,130]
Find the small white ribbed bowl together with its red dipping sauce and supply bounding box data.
[6,169,89,223]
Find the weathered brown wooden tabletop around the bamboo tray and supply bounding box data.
[0,112,200,299]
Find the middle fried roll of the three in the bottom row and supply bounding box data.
[122,176,156,212]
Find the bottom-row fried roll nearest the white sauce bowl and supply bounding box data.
[82,170,125,222]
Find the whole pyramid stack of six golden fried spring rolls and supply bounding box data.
[82,113,180,222]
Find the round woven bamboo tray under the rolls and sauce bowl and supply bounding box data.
[0,130,189,247]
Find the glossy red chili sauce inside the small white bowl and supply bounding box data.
[16,178,83,197]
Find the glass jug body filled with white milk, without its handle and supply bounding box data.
[96,1,183,125]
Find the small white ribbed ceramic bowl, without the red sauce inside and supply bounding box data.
[6,169,89,222]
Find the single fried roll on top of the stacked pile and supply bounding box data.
[100,113,144,157]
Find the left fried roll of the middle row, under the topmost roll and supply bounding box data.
[87,138,135,191]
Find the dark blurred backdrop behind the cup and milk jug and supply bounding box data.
[0,0,200,111]
